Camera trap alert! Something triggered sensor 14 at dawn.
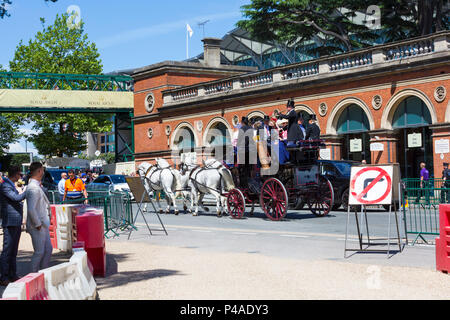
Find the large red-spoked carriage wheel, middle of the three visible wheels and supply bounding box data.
[259,178,288,221]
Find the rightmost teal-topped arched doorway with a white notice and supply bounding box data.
[392,96,433,178]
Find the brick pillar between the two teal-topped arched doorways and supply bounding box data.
[369,131,398,164]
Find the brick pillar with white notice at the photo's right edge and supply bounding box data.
[430,123,450,179]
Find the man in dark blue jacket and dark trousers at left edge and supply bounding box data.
[0,166,26,286]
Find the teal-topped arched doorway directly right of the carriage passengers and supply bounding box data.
[336,104,370,163]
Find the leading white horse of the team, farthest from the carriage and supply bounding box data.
[138,158,186,215]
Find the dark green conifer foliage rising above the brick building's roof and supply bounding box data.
[237,0,449,55]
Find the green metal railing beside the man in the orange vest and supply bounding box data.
[49,192,137,238]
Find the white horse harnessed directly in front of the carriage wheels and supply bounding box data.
[181,159,234,217]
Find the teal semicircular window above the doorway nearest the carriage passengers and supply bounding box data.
[336,104,370,134]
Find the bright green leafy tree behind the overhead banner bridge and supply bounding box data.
[9,14,112,157]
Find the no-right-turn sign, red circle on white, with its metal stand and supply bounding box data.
[344,164,402,258]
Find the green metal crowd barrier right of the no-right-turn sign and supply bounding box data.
[401,179,442,245]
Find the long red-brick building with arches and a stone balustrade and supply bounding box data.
[132,31,450,178]
